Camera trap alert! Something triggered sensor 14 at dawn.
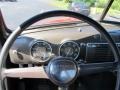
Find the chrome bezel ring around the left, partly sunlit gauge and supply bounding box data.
[30,40,52,63]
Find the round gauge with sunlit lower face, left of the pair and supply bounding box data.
[31,41,52,62]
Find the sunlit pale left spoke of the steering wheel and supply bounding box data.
[2,67,48,79]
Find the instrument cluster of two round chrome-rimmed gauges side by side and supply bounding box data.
[30,40,80,62]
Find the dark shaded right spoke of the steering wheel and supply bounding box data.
[79,62,118,75]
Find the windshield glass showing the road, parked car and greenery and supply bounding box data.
[0,0,120,30]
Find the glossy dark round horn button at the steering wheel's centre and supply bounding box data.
[47,57,78,86]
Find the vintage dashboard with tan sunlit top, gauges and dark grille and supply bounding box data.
[9,24,120,64]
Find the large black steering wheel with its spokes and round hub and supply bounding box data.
[0,10,120,90]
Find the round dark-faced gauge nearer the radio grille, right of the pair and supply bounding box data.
[59,41,80,60]
